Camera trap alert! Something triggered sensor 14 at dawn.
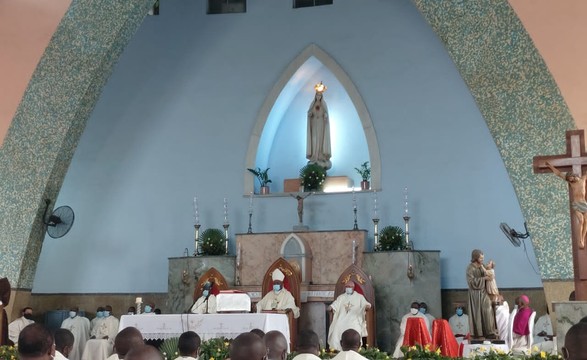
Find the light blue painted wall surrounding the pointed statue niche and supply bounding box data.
[33,0,541,293]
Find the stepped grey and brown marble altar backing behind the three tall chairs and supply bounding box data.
[167,230,442,352]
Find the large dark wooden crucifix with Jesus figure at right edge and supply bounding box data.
[533,130,587,300]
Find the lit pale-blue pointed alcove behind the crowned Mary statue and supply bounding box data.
[244,44,381,194]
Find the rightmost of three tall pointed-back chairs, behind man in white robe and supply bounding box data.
[330,264,377,347]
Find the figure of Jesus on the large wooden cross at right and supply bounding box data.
[546,161,587,249]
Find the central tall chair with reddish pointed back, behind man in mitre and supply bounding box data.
[261,257,302,349]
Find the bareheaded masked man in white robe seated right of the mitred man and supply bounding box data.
[328,280,371,351]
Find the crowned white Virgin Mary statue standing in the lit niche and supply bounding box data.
[306,82,332,170]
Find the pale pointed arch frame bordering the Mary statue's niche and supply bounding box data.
[244,44,381,194]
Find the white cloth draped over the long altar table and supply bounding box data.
[118,313,290,341]
